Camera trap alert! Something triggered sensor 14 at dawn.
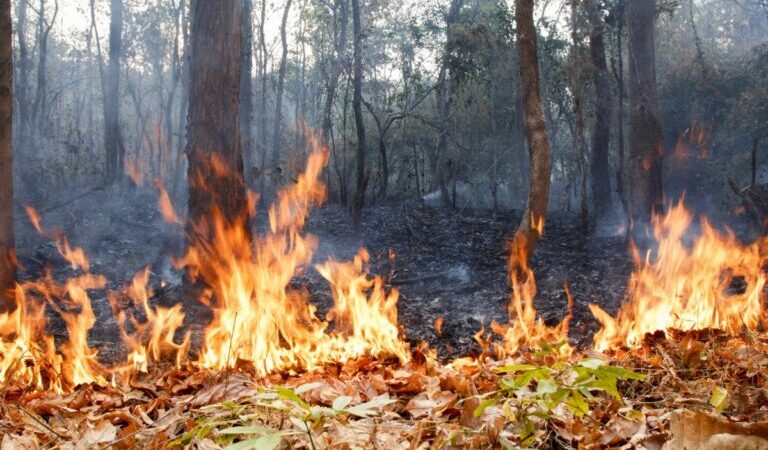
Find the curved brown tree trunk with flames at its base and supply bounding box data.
[511,0,552,269]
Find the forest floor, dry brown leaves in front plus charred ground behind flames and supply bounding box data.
[7,184,768,450]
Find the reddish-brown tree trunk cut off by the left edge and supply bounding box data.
[0,0,16,311]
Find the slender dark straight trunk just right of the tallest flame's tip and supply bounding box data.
[350,0,368,230]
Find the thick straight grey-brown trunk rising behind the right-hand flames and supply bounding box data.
[628,0,664,239]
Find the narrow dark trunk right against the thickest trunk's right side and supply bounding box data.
[240,0,253,171]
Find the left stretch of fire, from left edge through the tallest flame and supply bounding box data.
[0,145,409,391]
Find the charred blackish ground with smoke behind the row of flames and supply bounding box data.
[16,185,631,359]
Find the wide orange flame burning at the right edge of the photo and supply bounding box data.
[590,200,766,350]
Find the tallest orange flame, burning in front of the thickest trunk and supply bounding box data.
[176,138,408,375]
